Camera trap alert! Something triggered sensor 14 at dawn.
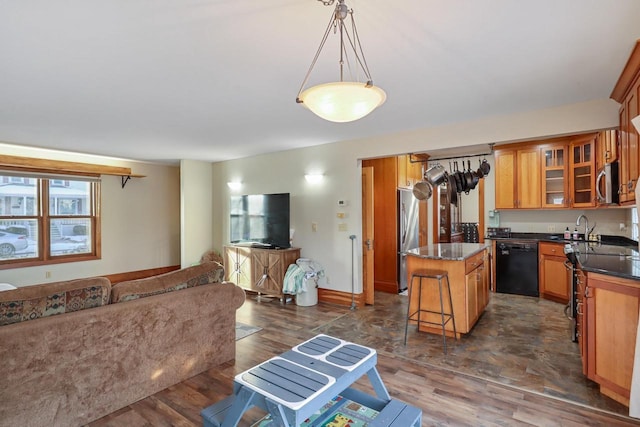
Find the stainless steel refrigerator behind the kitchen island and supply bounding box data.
[397,189,420,292]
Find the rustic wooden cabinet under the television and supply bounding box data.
[224,246,300,302]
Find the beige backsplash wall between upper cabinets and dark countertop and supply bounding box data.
[487,208,637,238]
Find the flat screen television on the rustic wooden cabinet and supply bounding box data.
[230,193,291,249]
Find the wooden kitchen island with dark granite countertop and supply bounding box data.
[407,243,490,338]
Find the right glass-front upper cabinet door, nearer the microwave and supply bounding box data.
[569,134,597,208]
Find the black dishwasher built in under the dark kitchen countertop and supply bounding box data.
[496,240,539,297]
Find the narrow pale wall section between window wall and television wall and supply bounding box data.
[180,160,213,268]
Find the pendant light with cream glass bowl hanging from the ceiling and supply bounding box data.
[296,0,387,123]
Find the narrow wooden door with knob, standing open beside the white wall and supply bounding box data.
[362,166,374,304]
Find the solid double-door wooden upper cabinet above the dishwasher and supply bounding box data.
[495,146,541,209]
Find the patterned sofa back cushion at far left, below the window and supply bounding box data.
[0,277,111,325]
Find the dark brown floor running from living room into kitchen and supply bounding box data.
[89,293,640,427]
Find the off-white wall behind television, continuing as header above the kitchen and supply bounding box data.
[213,100,619,292]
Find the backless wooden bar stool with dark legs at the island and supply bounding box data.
[404,269,457,354]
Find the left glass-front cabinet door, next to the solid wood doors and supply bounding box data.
[542,145,569,208]
